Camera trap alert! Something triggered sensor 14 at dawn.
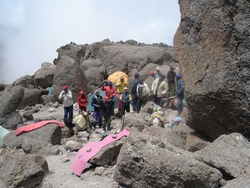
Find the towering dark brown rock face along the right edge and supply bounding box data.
[174,0,250,140]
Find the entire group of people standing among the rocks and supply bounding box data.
[58,67,184,131]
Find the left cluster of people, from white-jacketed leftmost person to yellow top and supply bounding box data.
[58,77,131,131]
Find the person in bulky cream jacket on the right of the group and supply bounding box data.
[151,74,168,106]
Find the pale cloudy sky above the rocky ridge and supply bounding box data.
[0,0,180,84]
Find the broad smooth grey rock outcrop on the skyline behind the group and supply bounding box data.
[82,41,174,77]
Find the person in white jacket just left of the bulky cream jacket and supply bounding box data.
[136,78,150,114]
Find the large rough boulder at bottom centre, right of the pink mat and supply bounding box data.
[114,133,222,188]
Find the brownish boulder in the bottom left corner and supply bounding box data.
[0,153,49,187]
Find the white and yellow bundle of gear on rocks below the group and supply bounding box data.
[148,105,164,128]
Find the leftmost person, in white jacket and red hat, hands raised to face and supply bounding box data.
[58,86,73,120]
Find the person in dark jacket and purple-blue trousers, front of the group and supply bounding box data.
[91,90,103,129]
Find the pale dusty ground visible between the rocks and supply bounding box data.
[30,105,177,188]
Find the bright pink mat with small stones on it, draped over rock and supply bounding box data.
[71,129,130,176]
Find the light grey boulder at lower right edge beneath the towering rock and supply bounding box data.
[194,133,250,180]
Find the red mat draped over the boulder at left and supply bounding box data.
[16,120,64,136]
